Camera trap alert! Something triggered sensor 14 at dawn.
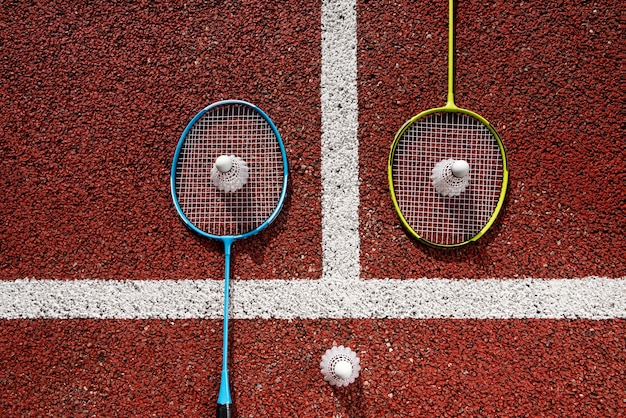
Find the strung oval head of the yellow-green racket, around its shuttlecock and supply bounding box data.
[387,105,509,248]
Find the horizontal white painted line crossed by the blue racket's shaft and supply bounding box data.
[0,277,626,320]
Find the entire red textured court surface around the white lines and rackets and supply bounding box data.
[0,0,626,418]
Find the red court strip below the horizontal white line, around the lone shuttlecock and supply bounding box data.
[0,320,625,417]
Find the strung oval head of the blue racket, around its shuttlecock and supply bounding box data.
[170,100,289,242]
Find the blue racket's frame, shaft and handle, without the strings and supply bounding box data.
[170,100,289,417]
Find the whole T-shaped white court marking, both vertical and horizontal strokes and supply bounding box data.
[0,0,626,319]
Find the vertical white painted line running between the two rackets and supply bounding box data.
[321,0,360,281]
